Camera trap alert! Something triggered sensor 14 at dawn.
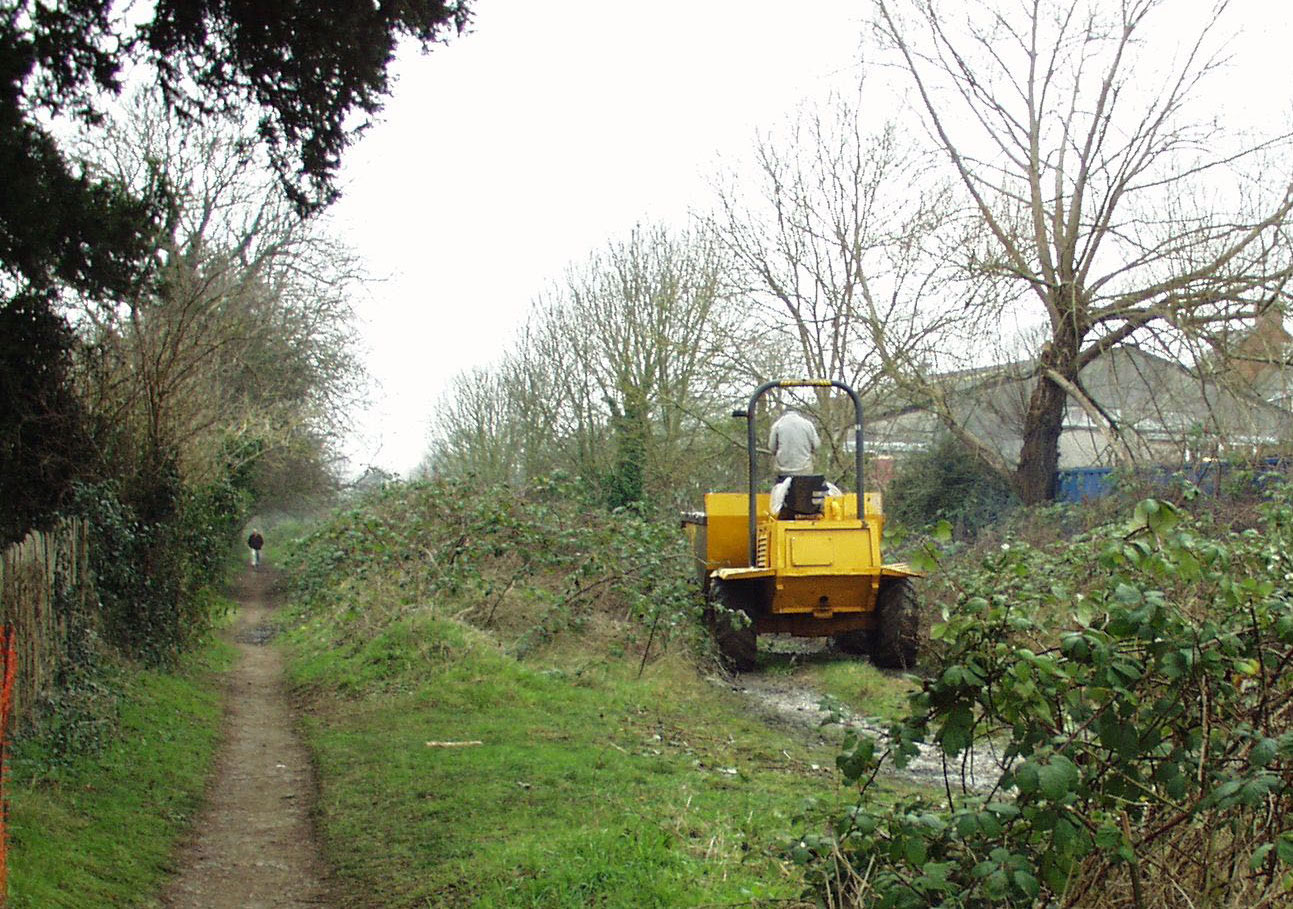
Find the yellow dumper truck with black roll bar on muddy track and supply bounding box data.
[683,379,919,670]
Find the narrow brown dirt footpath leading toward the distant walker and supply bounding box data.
[162,565,332,909]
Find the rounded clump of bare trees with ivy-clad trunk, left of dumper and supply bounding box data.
[433,226,740,502]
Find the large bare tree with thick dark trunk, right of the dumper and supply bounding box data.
[877,0,1293,503]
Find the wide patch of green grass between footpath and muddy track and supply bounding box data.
[292,608,889,908]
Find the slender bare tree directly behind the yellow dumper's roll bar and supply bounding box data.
[712,88,989,475]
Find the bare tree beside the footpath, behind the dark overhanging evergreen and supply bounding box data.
[75,96,358,496]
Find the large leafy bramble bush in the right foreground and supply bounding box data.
[794,486,1293,909]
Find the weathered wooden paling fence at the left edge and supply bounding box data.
[0,520,89,728]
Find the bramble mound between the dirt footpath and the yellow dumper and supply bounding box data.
[284,475,700,659]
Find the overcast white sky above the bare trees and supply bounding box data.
[334,0,1293,475]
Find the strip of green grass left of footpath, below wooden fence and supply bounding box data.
[8,643,233,908]
